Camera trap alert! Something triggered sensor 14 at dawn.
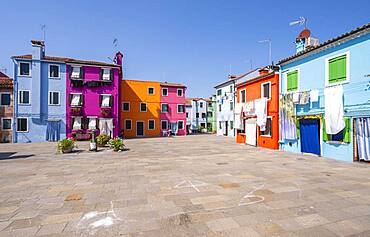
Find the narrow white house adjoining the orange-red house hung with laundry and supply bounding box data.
[214,69,258,137]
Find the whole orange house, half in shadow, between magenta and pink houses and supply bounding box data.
[120,80,161,138]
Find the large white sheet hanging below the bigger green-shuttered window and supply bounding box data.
[324,85,346,134]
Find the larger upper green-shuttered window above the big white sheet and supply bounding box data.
[327,53,348,84]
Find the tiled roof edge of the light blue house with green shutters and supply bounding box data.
[278,23,370,64]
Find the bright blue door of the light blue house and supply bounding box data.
[299,119,320,155]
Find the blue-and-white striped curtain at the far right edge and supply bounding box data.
[356,118,370,160]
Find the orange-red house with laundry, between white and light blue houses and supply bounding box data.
[235,67,279,149]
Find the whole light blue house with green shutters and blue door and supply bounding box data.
[278,24,370,162]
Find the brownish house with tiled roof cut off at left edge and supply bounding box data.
[0,72,14,143]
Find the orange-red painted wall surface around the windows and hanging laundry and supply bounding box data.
[237,74,279,149]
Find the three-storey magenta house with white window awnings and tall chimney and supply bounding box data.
[66,52,122,140]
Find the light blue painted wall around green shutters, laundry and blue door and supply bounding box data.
[280,34,370,162]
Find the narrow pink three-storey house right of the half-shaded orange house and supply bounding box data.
[160,82,186,136]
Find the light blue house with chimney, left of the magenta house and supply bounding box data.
[12,40,66,142]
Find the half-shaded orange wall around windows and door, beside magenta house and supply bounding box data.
[120,80,161,138]
